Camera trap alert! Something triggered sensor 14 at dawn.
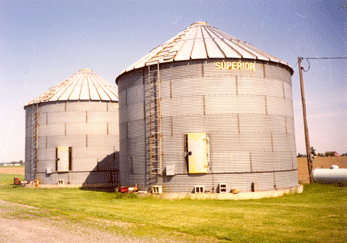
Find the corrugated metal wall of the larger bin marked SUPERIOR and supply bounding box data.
[118,60,298,192]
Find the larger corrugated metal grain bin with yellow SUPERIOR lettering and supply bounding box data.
[116,22,298,192]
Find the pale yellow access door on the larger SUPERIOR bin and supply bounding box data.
[187,133,209,174]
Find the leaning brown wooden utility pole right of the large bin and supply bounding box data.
[298,57,313,183]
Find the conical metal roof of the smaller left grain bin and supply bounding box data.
[27,69,118,105]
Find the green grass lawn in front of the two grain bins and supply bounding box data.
[0,177,347,242]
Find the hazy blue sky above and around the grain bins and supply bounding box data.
[0,0,347,162]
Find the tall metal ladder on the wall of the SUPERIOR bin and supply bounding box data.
[145,62,162,186]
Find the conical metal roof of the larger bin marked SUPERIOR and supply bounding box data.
[120,22,290,74]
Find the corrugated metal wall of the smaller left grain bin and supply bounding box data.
[25,101,119,185]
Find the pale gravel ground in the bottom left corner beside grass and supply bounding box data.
[0,199,160,243]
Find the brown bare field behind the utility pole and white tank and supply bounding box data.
[297,156,347,183]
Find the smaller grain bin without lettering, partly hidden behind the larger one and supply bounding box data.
[24,69,119,185]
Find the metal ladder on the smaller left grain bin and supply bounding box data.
[30,103,38,181]
